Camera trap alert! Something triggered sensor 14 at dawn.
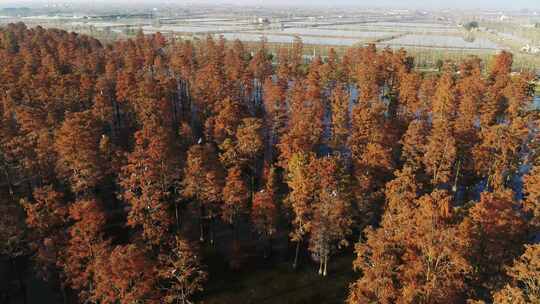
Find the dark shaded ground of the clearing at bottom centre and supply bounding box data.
[199,247,355,304]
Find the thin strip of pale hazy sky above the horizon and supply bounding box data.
[0,0,540,9]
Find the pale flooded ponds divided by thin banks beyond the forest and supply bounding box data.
[0,12,504,50]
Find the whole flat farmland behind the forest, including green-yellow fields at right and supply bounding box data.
[4,6,540,70]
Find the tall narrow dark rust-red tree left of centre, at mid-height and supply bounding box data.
[119,120,180,245]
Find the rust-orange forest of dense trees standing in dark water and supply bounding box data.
[0,23,540,304]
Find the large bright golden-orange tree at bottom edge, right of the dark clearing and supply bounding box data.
[403,191,471,303]
